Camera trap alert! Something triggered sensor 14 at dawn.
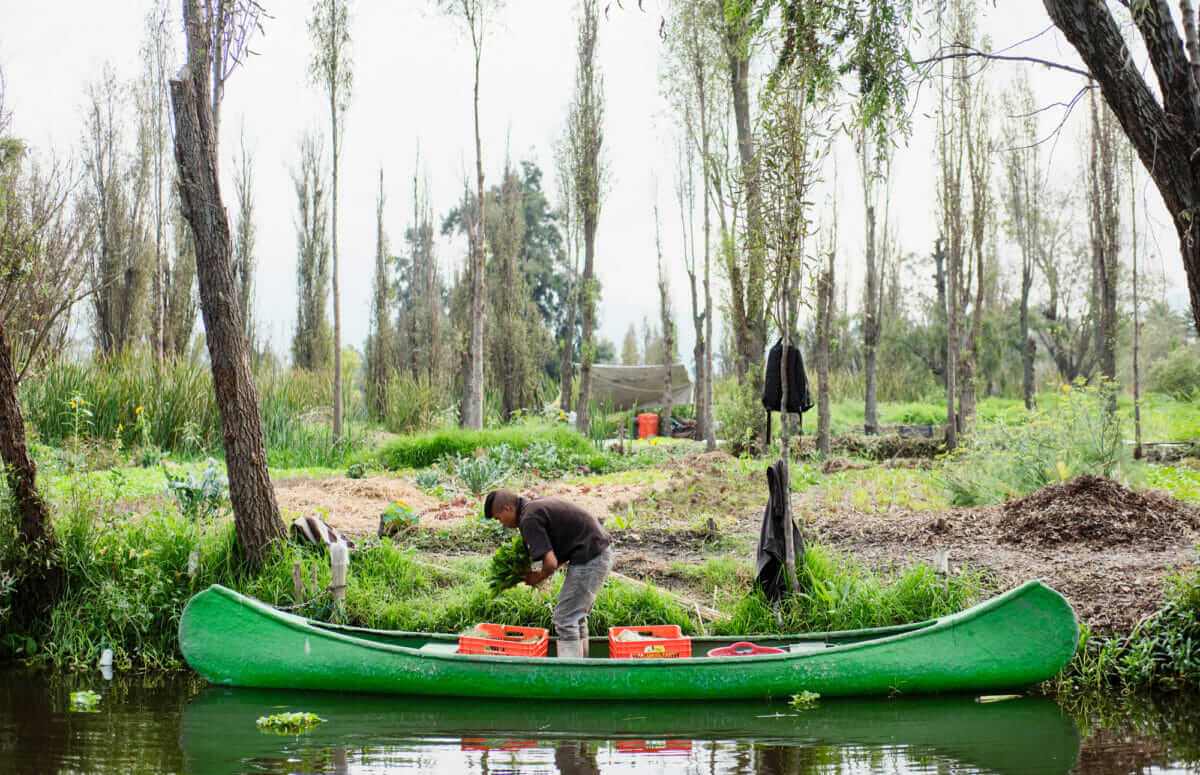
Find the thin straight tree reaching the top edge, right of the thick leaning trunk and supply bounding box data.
[308,0,354,441]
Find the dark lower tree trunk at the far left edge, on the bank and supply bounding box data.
[0,320,61,619]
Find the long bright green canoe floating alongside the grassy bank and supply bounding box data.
[179,582,1079,701]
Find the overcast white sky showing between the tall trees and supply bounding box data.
[0,0,1183,374]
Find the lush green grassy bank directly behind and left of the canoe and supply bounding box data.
[0,479,980,669]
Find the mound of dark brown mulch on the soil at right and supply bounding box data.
[997,474,1200,546]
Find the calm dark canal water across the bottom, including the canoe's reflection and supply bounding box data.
[0,672,1200,775]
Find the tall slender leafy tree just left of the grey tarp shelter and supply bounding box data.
[568,0,604,433]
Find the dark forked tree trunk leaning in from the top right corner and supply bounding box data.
[1043,0,1200,332]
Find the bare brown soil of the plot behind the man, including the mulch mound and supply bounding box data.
[276,452,1200,633]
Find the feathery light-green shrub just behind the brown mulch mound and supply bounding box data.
[944,384,1133,506]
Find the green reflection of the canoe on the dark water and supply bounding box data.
[180,686,1079,774]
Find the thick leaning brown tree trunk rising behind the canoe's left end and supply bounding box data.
[170,6,284,566]
